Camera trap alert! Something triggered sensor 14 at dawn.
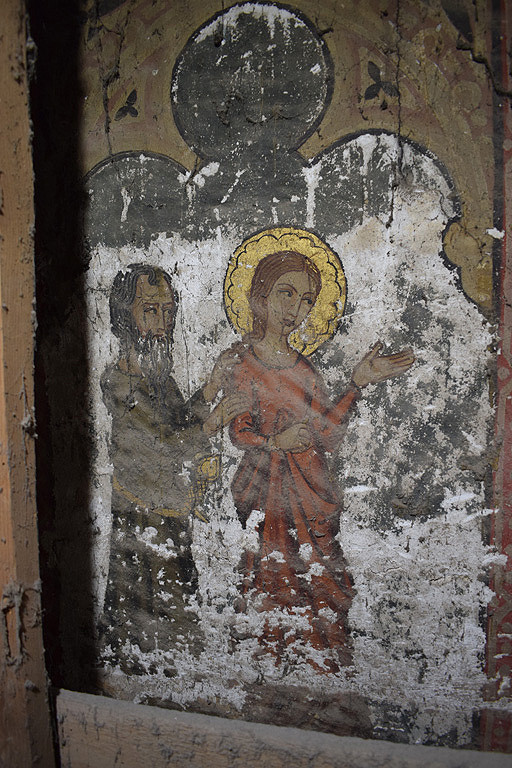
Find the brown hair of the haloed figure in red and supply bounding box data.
[247,251,322,341]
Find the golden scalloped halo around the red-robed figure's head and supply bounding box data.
[224,227,347,355]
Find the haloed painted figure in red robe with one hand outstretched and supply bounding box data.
[226,230,414,671]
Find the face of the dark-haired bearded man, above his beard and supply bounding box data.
[132,275,176,339]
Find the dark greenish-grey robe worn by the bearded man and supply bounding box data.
[101,367,210,674]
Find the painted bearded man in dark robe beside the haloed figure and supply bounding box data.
[101,264,247,674]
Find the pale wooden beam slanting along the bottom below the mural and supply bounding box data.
[57,691,510,768]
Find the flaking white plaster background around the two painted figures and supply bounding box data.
[64,135,505,744]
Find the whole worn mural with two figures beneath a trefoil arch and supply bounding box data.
[39,0,512,746]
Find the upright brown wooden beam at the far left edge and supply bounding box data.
[0,0,55,768]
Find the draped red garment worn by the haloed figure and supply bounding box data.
[230,350,358,671]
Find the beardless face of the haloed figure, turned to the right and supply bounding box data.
[267,272,316,336]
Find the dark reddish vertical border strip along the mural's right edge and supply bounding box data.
[481,2,512,752]
